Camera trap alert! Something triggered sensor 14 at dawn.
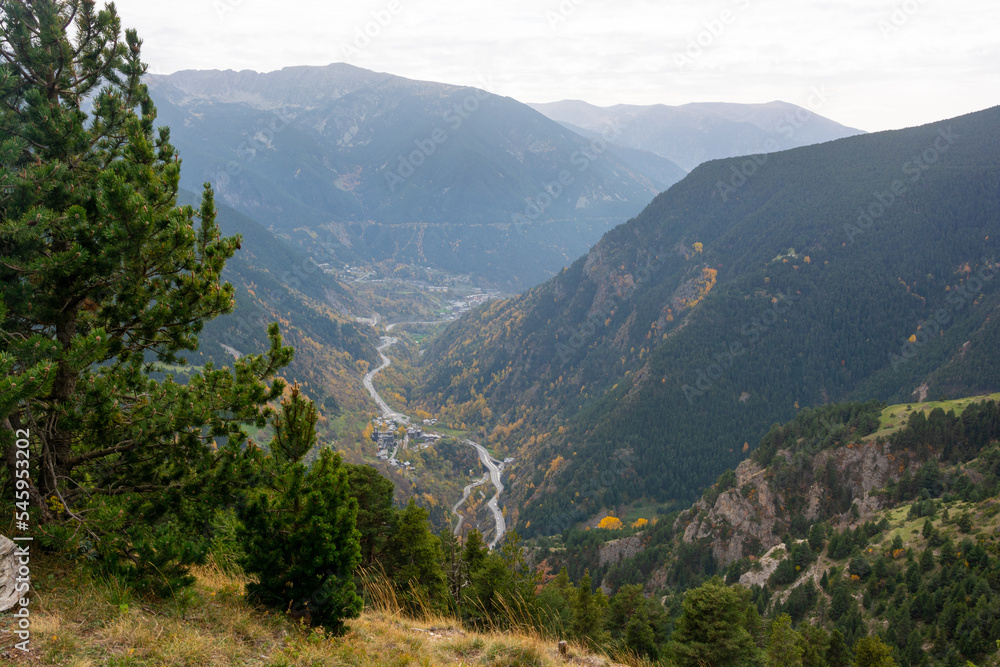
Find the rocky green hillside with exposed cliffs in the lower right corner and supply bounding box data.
[534,396,1000,666]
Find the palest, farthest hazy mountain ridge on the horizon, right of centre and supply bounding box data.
[529,99,863,170]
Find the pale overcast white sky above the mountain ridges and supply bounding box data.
[116,0,1000,131]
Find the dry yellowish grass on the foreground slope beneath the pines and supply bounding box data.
[0,560,624,667]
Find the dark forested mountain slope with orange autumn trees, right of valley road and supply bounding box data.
[411,107,1000,535]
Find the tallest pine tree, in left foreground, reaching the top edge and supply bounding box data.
[0,0,292,592]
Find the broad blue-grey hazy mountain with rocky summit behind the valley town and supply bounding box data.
[148,64,684,290]
